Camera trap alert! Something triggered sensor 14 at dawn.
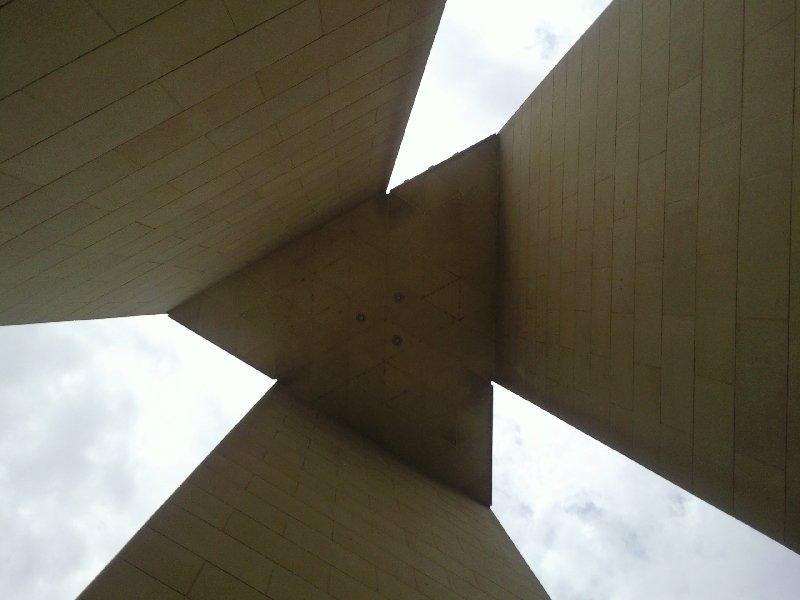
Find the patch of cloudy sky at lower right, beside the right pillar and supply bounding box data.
[492,386,800,600]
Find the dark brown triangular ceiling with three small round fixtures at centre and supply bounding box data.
[170,136,499,506]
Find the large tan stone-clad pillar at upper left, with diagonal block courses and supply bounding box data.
[0,0,444,325]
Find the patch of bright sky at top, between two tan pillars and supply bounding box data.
[389,0,609,189]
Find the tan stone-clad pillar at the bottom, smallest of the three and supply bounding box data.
[79,384,549,600]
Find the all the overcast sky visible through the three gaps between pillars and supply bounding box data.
[0,0,800,600]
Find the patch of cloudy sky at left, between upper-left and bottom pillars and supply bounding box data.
[0,317,269,600]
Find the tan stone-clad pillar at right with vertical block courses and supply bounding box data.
[496,0,800,551]
